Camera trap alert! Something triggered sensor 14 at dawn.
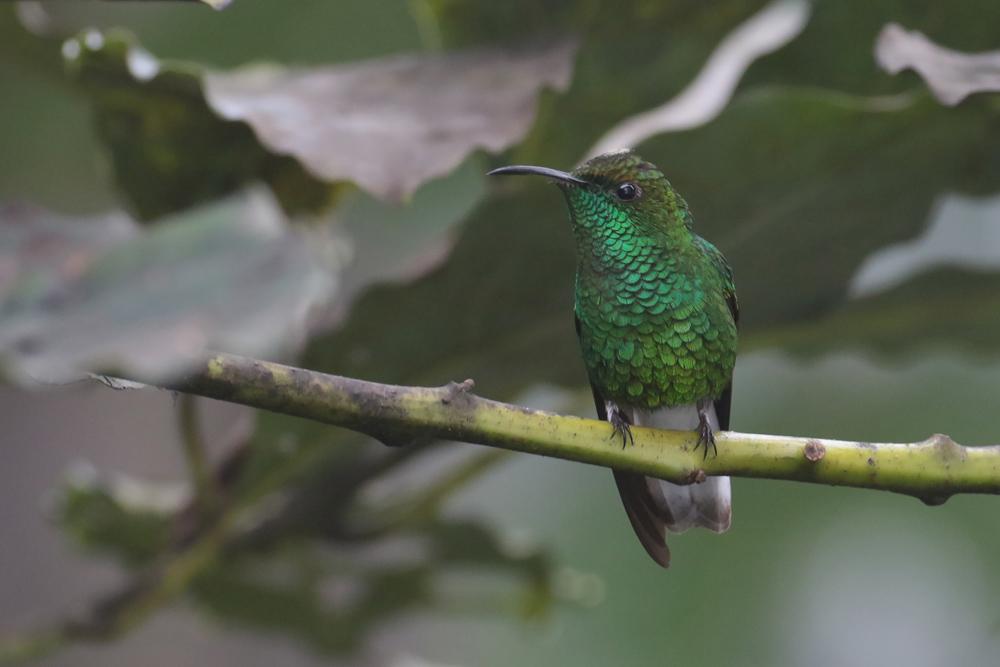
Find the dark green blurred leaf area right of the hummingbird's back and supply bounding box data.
[642,89,1000,351]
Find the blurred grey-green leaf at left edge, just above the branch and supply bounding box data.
[0,190,333,380]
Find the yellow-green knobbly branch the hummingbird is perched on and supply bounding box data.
[170,354,1000,505]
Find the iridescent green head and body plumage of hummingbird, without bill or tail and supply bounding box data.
[565,153,737,409]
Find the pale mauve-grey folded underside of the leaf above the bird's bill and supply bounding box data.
[205,39,576,200]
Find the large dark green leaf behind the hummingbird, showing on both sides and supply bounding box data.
[303,14,1000,399]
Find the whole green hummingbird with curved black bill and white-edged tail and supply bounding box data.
[490,151,739,567]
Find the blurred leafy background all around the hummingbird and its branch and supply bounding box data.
[0,0,1000,667]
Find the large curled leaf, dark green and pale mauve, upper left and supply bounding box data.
[50,24,575,214]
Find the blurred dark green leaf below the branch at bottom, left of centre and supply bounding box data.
[194,521,552,655]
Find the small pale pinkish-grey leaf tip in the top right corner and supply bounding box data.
[875,23,1000,106]
